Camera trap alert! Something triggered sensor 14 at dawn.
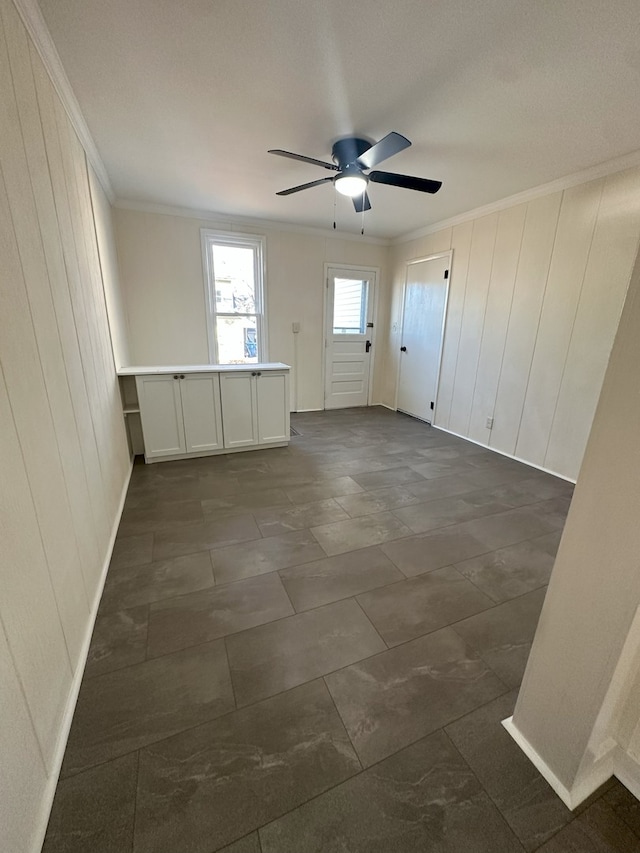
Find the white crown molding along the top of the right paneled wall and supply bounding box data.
[390,146,640,246]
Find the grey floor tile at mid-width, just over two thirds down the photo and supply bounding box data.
[280,547,404,611]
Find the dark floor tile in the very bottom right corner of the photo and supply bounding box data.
[538,800,640,853]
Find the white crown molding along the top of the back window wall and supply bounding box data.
[113,198,392,246]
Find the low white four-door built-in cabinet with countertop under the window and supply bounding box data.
[120,364,290,462]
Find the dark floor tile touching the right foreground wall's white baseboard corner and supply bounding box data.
[445,691,573,851]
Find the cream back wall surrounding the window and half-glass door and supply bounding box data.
[115,208,388,410]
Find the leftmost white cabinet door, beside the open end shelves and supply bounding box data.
[136,373,186,459]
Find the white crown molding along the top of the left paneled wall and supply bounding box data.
[13,0,115,204]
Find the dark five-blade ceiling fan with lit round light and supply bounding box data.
[268,131,442,213]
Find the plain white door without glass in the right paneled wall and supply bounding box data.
[397,254,451,423]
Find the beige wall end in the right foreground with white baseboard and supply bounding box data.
[513,235,640,806]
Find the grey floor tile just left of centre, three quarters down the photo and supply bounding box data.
[226,599,385,707]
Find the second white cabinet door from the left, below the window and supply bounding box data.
[180,373,223,453]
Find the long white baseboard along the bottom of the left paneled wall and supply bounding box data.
[33,459,133,853]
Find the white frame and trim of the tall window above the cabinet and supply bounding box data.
[200,228,269,367]
